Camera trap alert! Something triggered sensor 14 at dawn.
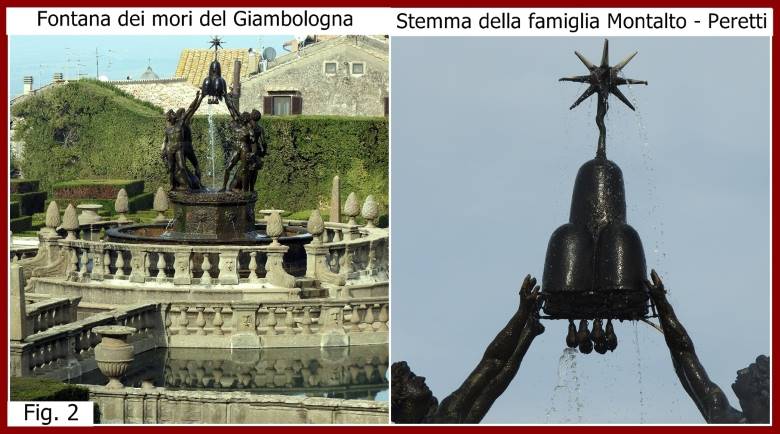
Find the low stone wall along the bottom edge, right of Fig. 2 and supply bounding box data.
[86,386,389,424]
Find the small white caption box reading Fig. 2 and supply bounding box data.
[8,401,95,426]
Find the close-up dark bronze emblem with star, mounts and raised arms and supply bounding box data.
[391,40,770,423]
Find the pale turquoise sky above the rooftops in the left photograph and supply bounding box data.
[9,35,292,97]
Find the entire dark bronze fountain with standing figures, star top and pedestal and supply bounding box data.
[107,37,311,254]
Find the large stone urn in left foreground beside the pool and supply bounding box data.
[92,325,136,389]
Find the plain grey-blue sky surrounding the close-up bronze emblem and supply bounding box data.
[391,37,770,423]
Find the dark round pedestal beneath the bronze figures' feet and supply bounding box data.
[168,191,257,241]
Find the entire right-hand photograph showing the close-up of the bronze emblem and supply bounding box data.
[390,37,771,424]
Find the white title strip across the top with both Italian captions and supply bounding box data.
[6,8,773,36]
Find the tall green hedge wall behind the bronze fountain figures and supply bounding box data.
[12,80,389,214]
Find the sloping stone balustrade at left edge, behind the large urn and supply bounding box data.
[11,303,165,379]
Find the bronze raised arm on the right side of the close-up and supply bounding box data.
[645,270,746,423]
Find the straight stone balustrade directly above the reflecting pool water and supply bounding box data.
[163,297,390,348]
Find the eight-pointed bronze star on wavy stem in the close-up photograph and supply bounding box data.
[558,39,647,158]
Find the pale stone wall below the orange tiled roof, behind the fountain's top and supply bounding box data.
[110,78,229,115]
